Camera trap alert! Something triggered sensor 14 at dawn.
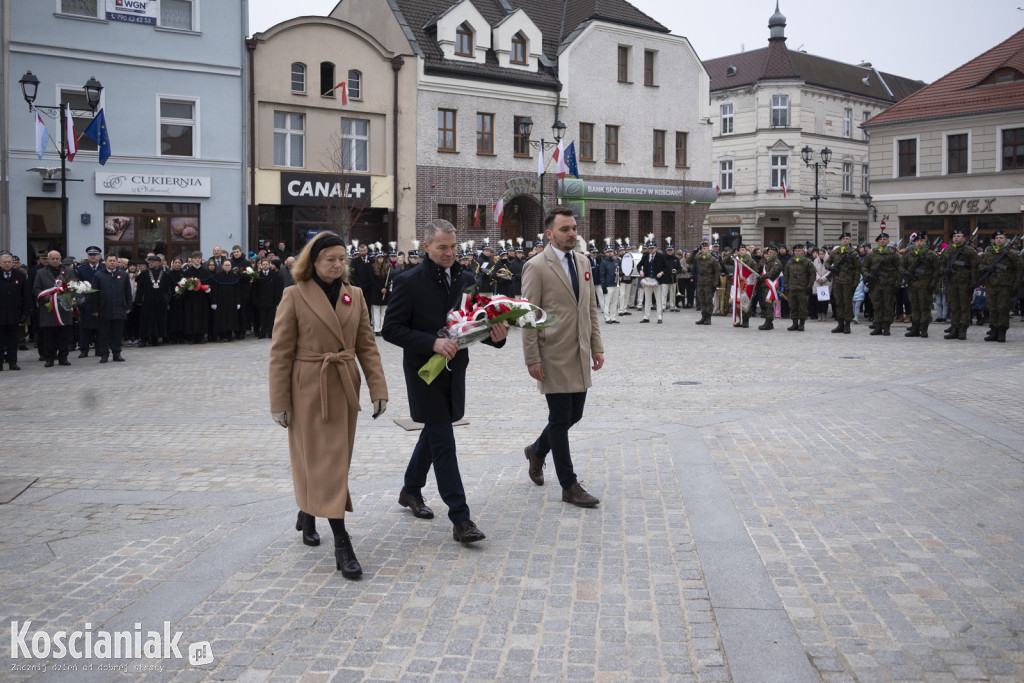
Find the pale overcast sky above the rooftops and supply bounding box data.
[249,0,1024,83]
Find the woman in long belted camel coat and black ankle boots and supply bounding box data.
[270,232,387,579]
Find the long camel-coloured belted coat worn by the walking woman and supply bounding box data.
[270,280,387,519]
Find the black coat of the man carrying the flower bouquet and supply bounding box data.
[381,258,505,423]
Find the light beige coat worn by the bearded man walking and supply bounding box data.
[522,245,604,393]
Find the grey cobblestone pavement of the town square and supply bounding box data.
[0,311,1024,682]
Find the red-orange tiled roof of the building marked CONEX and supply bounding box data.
[862,29,1024,126]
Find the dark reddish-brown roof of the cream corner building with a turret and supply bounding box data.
[703,41,925,102]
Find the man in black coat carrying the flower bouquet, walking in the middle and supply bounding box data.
[382,219,508,543]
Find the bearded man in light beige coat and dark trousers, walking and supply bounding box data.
[522,207,604,508]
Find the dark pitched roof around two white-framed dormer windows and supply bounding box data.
[388,0,669,89]
